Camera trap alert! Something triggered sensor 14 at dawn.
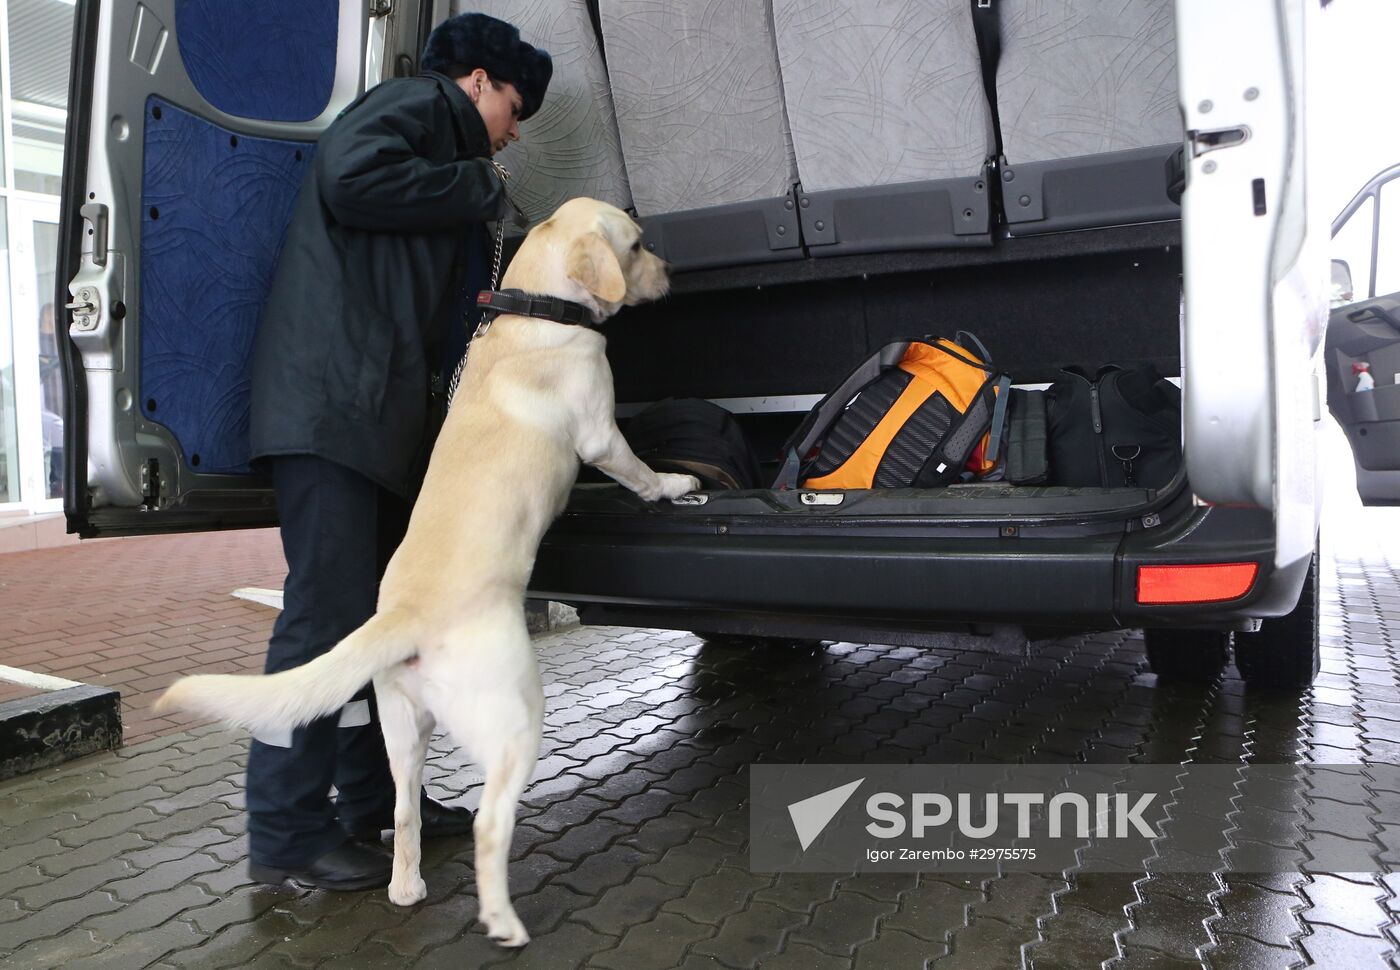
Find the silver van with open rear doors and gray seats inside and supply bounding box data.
[59,0,1400,689]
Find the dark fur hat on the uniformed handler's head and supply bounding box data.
[421,14,554,120]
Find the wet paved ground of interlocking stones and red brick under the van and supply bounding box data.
[0,495,1400,970]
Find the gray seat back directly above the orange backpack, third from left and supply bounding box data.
[773,0,991,256]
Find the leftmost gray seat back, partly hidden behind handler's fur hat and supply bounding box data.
[452,0,631,223]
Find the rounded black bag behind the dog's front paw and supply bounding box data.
[623,398,763,491]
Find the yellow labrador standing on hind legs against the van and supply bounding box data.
[158,199,700,946]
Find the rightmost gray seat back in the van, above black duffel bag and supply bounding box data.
[997,0,1183,235]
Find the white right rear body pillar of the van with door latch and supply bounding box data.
[1176,0,1329,567]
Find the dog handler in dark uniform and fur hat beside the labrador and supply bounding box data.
[248,14,553,889]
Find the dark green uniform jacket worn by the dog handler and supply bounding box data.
[251,73,505,494]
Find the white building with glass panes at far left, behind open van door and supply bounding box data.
[0,0,74,523]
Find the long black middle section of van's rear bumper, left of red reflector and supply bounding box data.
[531,535,1117,621]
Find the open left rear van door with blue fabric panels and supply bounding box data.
[55,0,383,536]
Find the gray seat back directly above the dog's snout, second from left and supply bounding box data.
[599,0,802,269]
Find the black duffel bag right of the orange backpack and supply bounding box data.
[1046,364,1182,488]
